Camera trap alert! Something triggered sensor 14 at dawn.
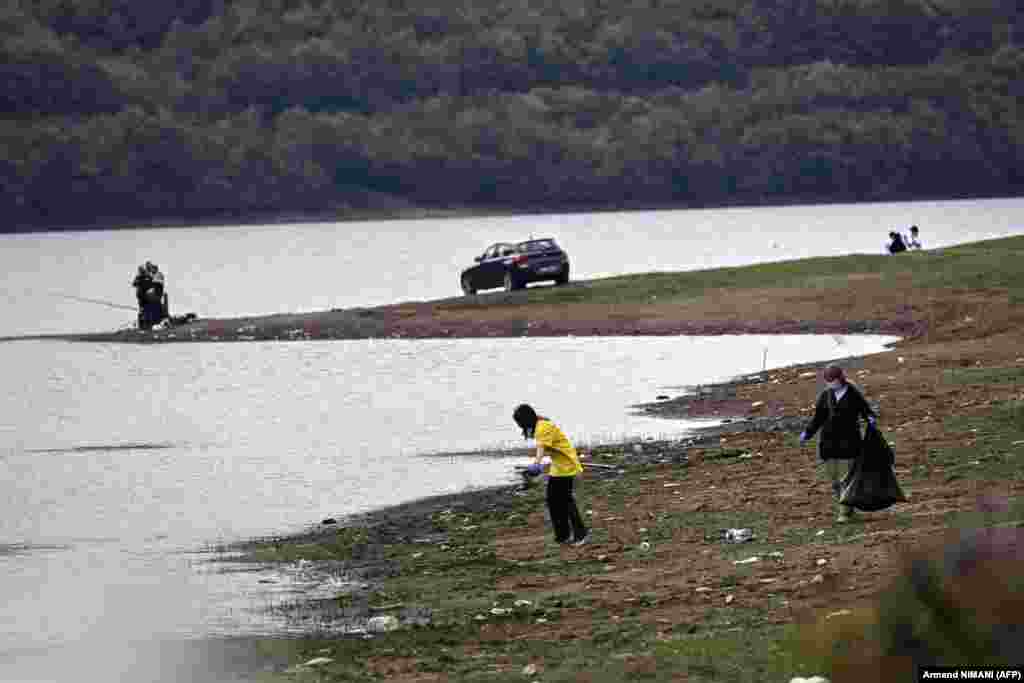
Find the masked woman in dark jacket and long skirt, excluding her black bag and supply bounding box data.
[800,366,876,522]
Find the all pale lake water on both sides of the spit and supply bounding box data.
[0,194,1024,683]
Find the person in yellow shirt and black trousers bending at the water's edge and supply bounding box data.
[512,403,589,546]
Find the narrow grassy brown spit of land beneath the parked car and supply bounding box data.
[41,237,1024,343]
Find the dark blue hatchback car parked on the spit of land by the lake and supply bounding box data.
[461,238,569,294]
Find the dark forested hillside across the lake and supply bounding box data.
[0,0,1024,231]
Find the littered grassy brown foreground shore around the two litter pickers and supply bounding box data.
[222,313,1024,683]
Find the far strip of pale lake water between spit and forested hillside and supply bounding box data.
[0,199,1024,337]
